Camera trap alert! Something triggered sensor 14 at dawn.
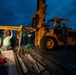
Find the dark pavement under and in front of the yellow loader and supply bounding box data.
[31,48,76,73]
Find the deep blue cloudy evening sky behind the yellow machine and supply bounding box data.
[0,0,76,30]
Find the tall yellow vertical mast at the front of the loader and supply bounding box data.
[32,0,47,46]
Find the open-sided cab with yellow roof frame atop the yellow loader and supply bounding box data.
[48,18,68,34]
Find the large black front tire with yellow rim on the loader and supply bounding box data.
[40,36,57,51]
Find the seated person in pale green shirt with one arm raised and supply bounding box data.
[2,30,13,50]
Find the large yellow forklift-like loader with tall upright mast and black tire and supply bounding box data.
[32,0,76,51]
